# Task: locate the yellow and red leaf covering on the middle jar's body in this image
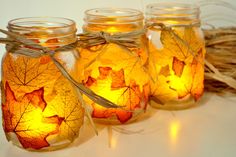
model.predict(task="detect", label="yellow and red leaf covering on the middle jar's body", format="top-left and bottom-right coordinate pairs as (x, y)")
top-left (78, 43), bottom-right (150, 123)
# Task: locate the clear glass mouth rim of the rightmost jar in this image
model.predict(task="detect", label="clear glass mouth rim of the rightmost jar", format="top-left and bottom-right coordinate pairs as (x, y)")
top-left (146, 2), bottom-right (200, 18)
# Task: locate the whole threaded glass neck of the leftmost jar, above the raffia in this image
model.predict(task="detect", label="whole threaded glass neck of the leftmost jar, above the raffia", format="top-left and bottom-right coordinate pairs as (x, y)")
top-left (7, 17), bottom-right (77, 47)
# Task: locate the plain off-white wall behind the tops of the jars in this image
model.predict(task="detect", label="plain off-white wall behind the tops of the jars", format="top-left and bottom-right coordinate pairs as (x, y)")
top-left (0, 0), bottom-right (236, 54)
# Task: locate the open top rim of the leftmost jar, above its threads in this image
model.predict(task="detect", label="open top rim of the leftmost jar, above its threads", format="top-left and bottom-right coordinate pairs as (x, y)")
top-left (8, 17), bottom-right (75, 30)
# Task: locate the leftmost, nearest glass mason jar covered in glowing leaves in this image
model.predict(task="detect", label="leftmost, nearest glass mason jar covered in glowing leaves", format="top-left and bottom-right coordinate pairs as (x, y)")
top-left (2, 17), bottom-right (84, 151)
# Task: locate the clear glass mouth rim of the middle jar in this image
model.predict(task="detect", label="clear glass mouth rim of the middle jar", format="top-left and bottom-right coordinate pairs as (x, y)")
top-left (84, 8), bottom-right (144, 23)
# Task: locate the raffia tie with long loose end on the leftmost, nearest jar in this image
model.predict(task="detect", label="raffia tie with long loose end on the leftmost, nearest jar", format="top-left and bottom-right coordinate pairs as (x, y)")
top-left (0, 29), bottom-right (123, 108)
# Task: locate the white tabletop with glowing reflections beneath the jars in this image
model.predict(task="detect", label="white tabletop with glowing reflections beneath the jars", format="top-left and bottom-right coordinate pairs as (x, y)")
top-left (0, 93), bottom-right (236, 157)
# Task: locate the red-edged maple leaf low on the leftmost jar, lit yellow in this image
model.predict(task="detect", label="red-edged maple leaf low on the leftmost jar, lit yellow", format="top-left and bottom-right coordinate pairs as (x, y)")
top-left (2, 82), bottom-right (64, 149)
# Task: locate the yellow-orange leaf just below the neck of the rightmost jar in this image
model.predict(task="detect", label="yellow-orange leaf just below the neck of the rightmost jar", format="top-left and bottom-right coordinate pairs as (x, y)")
top-left (161, 27), bottom-right (204, 63)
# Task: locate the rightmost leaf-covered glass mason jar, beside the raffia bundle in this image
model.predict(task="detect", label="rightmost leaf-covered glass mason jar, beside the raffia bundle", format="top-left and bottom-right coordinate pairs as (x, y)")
top-left (146, 3), bottom-right (205, 110)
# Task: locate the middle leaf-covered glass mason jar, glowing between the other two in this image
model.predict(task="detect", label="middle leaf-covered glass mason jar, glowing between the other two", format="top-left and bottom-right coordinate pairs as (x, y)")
top-left (77, 8), bottom-right (149, 124)
